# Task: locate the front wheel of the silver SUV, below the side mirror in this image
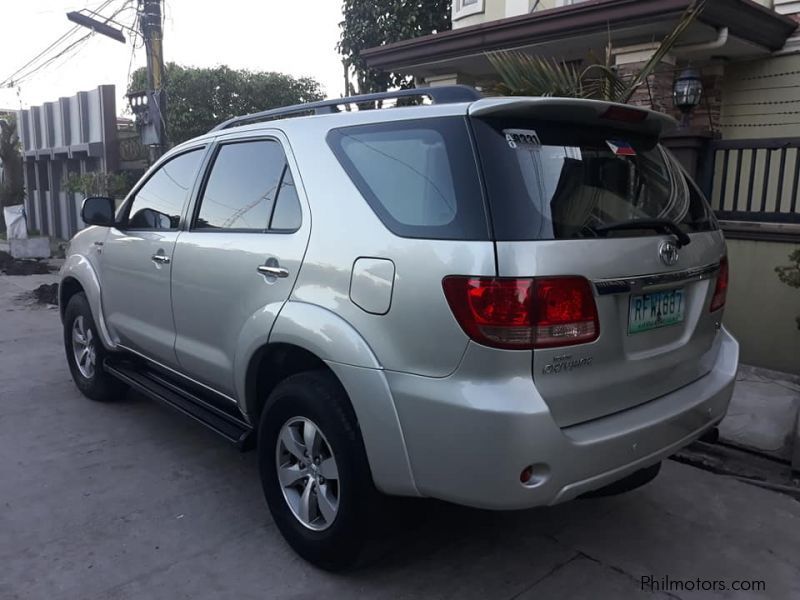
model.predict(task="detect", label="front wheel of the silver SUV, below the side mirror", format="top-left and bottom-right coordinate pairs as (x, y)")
top-left (64, 292), bottom-right (125, 402)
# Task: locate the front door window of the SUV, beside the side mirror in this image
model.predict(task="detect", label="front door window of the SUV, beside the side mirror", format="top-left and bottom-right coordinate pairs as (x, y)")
top-left (128, 148), bottom-right (203, 229)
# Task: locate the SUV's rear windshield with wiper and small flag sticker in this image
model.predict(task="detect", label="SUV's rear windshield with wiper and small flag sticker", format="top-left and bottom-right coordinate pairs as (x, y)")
top-left (473, 119), bottom-right (717, 240)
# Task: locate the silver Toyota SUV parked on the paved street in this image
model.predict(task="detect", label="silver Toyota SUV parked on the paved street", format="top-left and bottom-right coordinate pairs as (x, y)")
top-left (60, 86), bottom-right (738, 569)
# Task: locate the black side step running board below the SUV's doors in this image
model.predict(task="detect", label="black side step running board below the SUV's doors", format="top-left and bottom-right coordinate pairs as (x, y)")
top-left (103, 360), bottom-right (253, 450)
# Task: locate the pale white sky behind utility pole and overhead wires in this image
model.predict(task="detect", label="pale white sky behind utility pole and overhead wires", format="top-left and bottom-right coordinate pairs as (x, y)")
top-left (0, 0), bottom-right (344, 115)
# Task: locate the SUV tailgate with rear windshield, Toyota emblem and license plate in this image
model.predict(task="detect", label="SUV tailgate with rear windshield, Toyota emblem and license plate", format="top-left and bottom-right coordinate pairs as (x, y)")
top-left (472, 114), bottom-right (725, 426)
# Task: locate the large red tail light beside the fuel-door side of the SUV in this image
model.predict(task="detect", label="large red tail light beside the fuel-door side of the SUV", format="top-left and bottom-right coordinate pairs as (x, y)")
top-left (442, 276), bottom-right (600, 350)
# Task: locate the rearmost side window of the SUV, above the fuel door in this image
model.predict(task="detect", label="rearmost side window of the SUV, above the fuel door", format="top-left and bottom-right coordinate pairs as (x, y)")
top-left (328, 117), bottom-right (488, 240)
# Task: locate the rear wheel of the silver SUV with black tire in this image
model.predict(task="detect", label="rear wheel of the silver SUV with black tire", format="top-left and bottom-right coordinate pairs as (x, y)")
top-left (258, 371), bottom-right (379, 571)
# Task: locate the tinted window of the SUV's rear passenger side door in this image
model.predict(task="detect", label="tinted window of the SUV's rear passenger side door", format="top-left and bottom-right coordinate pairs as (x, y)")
top-left (195, 140), bottom-right (286, 231)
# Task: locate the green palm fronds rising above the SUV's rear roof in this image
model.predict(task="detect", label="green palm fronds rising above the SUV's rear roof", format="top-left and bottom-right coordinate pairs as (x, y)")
top-left (486, 0), bottom-right (705, 103)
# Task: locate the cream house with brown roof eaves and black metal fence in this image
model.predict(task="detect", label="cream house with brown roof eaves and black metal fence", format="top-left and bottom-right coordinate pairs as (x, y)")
top-left (362, 0), bottom-right (800, 374)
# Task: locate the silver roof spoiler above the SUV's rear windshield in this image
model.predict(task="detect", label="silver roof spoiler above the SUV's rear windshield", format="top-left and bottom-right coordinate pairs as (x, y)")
top-left (468, 96), bottom-right (678, 137)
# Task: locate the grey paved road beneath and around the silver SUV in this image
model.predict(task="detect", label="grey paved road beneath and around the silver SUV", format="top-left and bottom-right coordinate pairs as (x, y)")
top-left (0, 276), bottom-right (800, 600)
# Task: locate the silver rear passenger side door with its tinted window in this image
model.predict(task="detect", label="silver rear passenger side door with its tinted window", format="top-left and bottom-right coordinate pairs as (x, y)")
top-left (172, 134), bottom-right (311, 397)
